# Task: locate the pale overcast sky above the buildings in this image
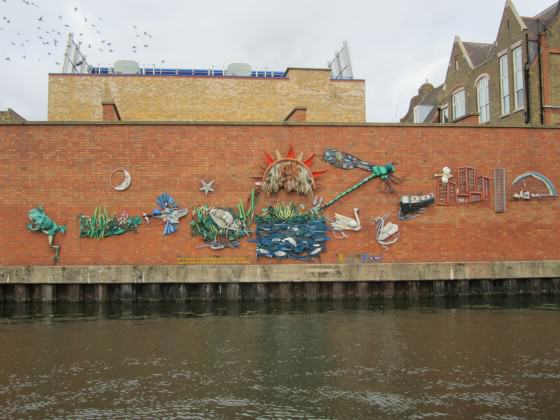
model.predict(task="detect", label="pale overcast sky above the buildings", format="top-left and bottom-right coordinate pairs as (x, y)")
top-left (0, 0), bottom-right (554, 122)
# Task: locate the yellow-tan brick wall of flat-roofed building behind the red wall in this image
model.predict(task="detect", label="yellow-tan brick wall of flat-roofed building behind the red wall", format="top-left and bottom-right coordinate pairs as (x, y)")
top-left (48, 68), bottom-right (365, 123)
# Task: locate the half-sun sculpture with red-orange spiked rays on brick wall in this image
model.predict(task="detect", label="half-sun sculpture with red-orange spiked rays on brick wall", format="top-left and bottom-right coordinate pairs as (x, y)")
top-left (260, 146), bottom-right (326, 195)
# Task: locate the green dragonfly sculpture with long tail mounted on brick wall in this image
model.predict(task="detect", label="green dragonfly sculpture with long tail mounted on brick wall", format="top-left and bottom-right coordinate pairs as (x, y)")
top-left (321, 149), bottom-right (404, 210)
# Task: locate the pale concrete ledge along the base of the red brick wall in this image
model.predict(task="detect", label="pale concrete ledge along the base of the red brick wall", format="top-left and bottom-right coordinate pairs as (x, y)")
top-left (0, 261), bottom-right (560, 284)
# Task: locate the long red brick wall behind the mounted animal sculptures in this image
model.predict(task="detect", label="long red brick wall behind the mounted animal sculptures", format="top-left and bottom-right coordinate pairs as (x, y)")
top-left (0, 124), bottom-right (560, 265)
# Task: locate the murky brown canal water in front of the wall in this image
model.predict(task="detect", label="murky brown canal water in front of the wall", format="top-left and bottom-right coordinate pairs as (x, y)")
top-left (0, 298), bottom-right (560, 419)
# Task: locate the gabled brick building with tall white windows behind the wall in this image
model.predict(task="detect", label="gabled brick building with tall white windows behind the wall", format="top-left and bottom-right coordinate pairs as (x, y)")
top-left (401, 0), bottom-right (560, 125)
